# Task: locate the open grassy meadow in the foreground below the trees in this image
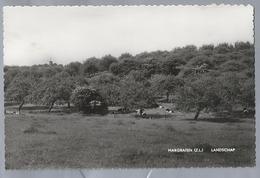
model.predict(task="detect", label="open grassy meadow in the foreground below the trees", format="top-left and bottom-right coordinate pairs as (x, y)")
top-left (5, 105), bottom-right (255, 169)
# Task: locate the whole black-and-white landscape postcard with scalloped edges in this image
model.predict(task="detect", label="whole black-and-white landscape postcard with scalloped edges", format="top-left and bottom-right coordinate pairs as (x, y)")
top-left (3, 4), bottom-right (256, 170)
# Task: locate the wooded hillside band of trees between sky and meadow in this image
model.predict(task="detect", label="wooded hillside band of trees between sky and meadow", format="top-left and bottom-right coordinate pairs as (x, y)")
top-left (4, 42), bottom-right (255, 119)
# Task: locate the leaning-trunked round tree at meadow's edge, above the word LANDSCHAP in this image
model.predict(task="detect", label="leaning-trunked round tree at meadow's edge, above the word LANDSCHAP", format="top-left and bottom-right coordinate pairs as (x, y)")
top-left (176, 75), bottom-right (221, 120)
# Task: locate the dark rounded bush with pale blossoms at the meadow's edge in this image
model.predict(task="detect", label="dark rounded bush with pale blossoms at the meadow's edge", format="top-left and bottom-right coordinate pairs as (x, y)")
top-left (71, 87), bottom-right (108, 114)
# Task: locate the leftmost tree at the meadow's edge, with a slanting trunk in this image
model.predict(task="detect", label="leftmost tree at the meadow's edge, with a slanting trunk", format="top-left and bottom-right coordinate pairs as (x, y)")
top-left (6, 75), bottom-right (32, 113)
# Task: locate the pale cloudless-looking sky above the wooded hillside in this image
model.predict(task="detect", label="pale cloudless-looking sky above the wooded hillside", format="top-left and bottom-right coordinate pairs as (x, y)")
top-left (4, 5), bottom-right (254, 65)
